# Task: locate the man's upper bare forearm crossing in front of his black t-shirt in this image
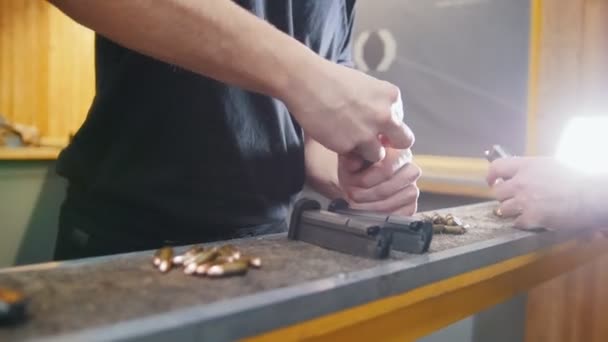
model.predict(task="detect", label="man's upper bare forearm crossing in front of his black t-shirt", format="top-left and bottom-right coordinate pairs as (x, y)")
top-left (49, 0), bottom-right (323, 98)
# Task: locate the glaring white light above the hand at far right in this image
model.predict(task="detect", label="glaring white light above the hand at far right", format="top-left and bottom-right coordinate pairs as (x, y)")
top-left (556, 115), bottom-right (608, 174)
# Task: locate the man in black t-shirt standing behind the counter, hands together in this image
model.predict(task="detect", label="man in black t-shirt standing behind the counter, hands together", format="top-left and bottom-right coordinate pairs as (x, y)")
top-left (51, 0), bottom-right (420, 259)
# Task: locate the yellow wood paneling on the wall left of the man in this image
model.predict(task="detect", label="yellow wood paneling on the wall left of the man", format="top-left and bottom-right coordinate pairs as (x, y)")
top-left (0, 0), bottom-right (95, 143)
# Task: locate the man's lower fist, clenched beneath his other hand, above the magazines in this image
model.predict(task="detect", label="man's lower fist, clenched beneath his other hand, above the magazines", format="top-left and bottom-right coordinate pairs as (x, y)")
top-left (338, 148), bottom-right (420, 216)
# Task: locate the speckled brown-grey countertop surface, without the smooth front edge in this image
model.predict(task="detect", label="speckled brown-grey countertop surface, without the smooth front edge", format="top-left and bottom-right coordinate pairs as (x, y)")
top-left (0, 203), bottom-right (530, 341)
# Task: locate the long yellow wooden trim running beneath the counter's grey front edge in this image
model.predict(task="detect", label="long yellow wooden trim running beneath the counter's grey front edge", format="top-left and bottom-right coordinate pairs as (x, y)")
top-left (246, 237), bottom-right (608, 342)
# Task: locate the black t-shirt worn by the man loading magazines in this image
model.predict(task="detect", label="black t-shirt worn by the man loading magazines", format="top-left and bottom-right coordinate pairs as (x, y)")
top-left (57, 0), bottom-right (354, 238)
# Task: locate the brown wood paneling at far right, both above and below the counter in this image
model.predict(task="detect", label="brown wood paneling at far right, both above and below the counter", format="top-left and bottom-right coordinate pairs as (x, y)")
top-left (526, 0), bottom-right (608, 342)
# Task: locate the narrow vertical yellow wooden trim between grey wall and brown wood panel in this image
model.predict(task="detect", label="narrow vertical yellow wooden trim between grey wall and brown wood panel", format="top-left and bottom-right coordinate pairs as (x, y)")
top-left (526, 0), bottom-right (543, 155)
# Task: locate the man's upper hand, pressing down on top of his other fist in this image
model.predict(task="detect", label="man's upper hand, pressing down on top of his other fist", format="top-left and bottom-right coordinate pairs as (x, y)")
top-left (282, 62), bottom-right (414, 162)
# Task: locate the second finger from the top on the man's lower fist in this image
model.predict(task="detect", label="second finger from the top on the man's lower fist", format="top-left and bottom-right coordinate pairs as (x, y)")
top-left (349, 164), bottom-right (421, 203)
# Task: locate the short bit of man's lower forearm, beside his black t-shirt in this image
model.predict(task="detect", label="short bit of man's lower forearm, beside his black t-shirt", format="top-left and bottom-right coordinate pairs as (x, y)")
top-left (305, 137), bottom-right (343, 199)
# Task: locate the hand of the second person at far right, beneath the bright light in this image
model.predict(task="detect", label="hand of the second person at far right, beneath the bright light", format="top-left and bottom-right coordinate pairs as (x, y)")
top-left (487, 158), bottom-right (594, 229)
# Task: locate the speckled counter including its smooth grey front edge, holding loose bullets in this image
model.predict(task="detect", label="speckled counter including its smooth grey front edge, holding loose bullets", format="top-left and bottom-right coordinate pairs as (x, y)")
top-left (0, 203), bottom-right (556, 341)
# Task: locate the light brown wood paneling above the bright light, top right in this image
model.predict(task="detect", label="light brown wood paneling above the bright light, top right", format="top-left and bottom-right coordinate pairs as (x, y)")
top-left (532, 0), bottom-right (608, 154)
